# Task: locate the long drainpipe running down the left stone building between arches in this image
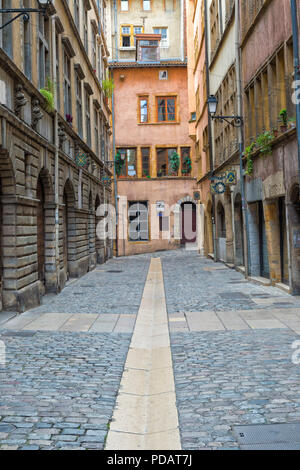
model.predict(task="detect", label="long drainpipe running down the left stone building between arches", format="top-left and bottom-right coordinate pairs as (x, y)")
top-left (52, 13), bottom-right (60, 291)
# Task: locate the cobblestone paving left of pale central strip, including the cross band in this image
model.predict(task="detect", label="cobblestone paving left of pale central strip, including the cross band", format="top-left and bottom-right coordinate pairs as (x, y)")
top-left (0, 257), bottom-right (150, 450)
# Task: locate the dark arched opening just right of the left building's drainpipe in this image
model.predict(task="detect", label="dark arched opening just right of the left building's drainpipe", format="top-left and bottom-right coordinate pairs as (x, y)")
top-left (63, 179), bottom-right (76, 279)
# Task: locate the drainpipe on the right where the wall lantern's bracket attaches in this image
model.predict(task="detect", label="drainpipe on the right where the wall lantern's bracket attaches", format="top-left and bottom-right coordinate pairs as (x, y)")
top-left (235, 0), bottom-right (251, 277)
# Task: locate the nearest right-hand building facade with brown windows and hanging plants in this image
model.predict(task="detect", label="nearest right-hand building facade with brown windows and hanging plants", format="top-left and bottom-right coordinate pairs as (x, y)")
top-left (241, 0), bottom-right (300, 293)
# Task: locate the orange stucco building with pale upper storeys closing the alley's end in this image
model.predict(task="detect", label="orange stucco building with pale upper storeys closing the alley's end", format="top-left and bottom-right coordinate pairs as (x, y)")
top-left (110, 2), bottom-right (198, 256)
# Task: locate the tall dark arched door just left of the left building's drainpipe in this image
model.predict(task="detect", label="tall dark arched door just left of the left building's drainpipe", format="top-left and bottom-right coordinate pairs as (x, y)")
top-left (37, 179), bottom-right (45, 284)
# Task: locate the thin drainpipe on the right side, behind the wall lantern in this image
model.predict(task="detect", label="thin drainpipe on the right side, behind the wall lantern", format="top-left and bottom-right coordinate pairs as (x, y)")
top-left (204, 0), bottom-right (217, 262)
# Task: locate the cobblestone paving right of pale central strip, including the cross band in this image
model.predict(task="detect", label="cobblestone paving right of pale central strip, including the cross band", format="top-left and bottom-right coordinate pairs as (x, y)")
top-left (162, 251), bottom-right (300, 450)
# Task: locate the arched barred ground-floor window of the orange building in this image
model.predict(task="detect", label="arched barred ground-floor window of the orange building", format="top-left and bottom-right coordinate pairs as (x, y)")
top-left (128, 201), bottom-right (149, 242)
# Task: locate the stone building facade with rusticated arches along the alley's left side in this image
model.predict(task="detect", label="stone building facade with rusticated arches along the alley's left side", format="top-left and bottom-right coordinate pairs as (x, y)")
top-left (0, 0), bottom-right (112, 312)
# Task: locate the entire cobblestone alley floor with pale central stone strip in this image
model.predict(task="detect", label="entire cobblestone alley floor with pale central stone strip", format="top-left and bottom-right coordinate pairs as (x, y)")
top-left (0, 250), bottom-right (300, 450)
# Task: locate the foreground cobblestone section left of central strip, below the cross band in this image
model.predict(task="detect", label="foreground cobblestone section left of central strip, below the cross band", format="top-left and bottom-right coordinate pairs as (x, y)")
top-left (0, 331), bottom-right (130, 450)
